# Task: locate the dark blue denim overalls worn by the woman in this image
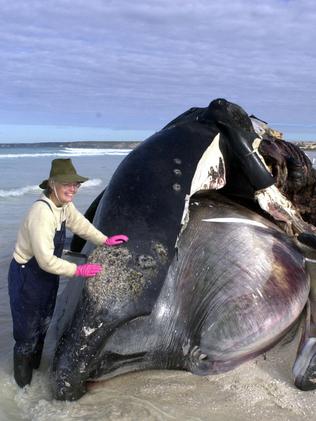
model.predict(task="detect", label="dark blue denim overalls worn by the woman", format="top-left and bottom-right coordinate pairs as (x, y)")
top-left (9, 200), bottom-right (66, 355)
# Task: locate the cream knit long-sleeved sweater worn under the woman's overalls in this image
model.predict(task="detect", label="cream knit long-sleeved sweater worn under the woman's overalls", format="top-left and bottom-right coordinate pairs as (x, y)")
top-left (13, 195), bottom-right (107, 276)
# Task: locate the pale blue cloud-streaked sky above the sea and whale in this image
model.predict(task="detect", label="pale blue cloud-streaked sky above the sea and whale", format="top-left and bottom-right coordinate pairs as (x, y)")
top-left (0, 0), bottom-right (316, 142)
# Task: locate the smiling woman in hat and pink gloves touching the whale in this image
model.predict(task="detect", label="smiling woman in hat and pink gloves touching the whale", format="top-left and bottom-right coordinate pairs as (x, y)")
top-left (9, 159), bottom-right (128, 387)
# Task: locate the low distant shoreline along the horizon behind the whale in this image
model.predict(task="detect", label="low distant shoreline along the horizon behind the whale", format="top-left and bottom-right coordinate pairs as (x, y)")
top-left (0, 140), bottom-right (316, 151)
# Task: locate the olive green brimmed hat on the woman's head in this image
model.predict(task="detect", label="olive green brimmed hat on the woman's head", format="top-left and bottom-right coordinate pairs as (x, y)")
top-left (39, 158), bottom-right (89, 189)
